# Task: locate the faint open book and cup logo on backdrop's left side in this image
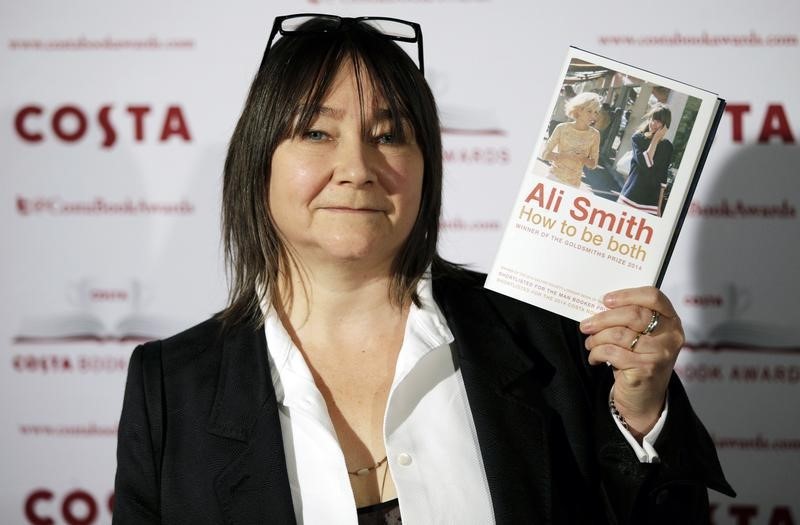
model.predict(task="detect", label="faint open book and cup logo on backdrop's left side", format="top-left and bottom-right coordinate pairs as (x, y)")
top-left (14, 279), bottom-right (186, 344)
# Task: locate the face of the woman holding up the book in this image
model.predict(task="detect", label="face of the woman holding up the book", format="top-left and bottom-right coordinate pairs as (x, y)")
top-left (269, 64), bottom-right (424, 270)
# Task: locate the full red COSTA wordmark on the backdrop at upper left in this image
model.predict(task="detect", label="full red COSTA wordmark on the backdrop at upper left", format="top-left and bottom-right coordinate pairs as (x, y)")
top-left (14, 104), bottom-right (192, 148)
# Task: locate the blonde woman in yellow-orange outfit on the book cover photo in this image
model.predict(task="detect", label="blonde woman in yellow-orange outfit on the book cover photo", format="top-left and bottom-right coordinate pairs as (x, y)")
top-left (542, 93), bottom-right (602, 188)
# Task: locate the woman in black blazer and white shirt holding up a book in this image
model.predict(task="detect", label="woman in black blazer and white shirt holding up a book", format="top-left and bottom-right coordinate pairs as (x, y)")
top-left (114, 16), bottom-right (730, 523)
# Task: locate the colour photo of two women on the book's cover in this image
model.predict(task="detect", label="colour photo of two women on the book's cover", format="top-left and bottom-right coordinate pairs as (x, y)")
top-left (530, 58), bottom-right (700, 216)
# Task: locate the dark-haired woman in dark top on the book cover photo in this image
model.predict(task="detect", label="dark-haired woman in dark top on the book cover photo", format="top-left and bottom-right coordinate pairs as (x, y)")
top-left (617, 103), bottom-right (673, 215)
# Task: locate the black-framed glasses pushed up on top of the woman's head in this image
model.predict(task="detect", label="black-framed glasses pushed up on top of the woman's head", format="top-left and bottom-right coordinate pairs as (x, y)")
top-left (261, 13), bottom-right (425, 75)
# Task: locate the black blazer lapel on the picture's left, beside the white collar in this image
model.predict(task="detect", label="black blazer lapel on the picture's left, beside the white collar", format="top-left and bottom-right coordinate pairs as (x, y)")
top-left (207, 327), bottom-right (295, 524)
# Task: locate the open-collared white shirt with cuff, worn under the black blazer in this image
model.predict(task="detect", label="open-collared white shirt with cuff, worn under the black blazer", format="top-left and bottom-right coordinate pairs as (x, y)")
top-left (264, 278), bottom-right (666, 525)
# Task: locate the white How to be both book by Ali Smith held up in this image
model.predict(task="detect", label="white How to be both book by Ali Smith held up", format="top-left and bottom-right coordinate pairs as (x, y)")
top-left (486, 47), bottom-right (725, 321)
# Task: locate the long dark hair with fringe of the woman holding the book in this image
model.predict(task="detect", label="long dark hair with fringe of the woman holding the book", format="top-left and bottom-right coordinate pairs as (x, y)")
top-left (218, 19), bottom-right (442, 325)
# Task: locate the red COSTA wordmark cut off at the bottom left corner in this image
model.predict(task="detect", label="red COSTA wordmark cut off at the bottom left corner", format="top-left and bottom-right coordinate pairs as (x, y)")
top-left (24, 489), bottom-right (114, 525)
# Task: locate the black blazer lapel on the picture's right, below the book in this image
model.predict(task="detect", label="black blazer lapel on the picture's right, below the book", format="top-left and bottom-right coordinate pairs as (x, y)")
top-left (434, 272), bottom-right (553, 524)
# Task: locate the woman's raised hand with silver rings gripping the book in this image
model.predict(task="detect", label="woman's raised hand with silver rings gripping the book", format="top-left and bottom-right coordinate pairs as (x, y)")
top-left (581, 286), bottom-right (684, 441)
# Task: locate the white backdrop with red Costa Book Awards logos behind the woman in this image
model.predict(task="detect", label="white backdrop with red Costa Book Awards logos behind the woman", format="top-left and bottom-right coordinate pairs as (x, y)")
top-left (0, 0), bottom-right (800, 525)
